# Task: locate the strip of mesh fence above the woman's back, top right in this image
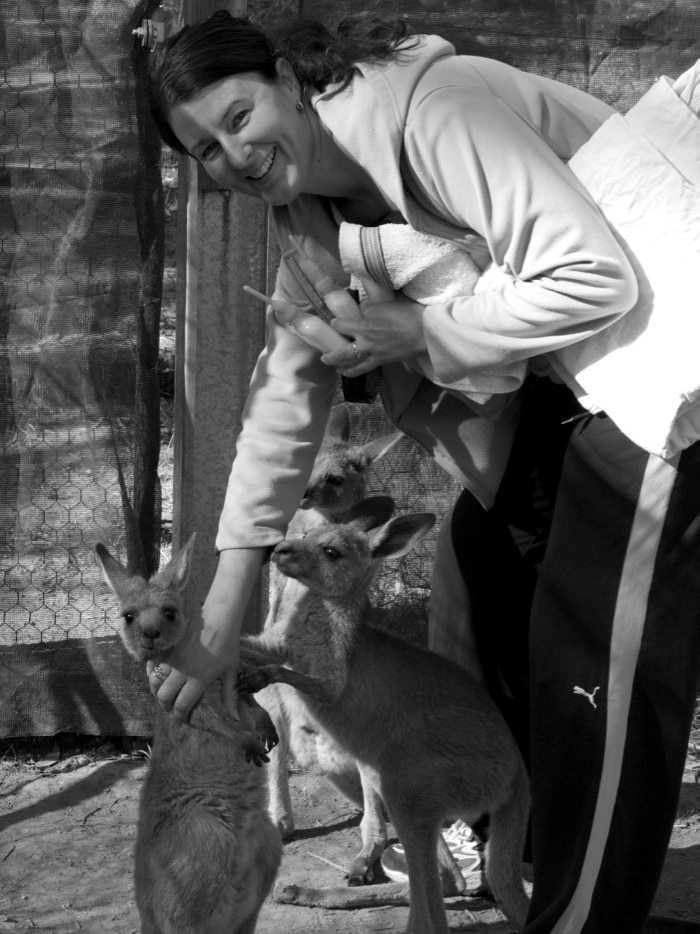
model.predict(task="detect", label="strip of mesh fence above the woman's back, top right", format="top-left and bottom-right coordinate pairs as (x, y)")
top-left (301, 0), bottom-right (700, 111)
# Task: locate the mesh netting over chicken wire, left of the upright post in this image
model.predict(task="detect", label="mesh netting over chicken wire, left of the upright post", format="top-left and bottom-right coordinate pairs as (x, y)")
top-left (0, 0), bottom-right (163, 733)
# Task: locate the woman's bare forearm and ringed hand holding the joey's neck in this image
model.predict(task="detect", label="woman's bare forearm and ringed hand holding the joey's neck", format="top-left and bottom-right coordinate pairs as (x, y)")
top-left (146, 548), bottom-right (265, 720)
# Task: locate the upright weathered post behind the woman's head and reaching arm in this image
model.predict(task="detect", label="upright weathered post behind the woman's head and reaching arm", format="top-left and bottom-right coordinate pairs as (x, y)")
top-left (173, 0), bottom-right (268, 630)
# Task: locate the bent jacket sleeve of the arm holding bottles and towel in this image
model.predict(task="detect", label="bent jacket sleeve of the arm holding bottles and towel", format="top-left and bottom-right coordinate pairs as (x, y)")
top-left (404, 86), bottom-right (637, 389)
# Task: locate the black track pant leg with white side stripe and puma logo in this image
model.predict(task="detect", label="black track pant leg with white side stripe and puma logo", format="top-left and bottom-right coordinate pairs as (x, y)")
top-left (526, 418), bottom-right (700, 934)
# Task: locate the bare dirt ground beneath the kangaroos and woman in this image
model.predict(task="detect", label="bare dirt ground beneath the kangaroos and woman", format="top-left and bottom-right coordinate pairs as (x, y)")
top-left (0, 740), bottom-right (700, 934)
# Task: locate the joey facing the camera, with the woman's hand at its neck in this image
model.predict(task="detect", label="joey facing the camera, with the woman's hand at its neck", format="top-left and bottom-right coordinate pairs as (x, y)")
top-left (95, 536), bottom-right (282, 934)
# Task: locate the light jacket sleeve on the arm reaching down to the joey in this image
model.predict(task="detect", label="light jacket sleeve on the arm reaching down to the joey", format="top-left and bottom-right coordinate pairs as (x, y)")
top-left (216, 268), bottom-right (337, 551)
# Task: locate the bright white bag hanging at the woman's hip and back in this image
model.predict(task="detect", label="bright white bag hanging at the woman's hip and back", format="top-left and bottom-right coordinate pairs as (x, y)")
top-left (550, 61), bottom-right (700, 458)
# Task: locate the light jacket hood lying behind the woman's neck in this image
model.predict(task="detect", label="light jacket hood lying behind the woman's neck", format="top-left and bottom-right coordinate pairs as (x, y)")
top-left (311, 36), bottom-right (455, 223)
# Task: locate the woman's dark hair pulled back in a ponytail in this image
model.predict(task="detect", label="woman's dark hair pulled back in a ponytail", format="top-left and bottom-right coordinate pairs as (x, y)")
top-left (150, 10), bottom-right (411, 152)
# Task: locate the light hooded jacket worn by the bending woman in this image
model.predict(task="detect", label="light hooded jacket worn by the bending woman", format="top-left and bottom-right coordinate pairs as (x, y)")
top-left (216, 36), bottom-right (637, 550)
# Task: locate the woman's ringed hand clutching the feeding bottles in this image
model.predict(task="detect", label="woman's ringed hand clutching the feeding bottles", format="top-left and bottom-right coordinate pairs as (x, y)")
top-left (321, 295), bottom-right (427, 376)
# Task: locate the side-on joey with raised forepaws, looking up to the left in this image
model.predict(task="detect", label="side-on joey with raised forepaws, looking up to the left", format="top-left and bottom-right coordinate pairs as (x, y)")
top-left (239, 498), bottom-right (529, 934)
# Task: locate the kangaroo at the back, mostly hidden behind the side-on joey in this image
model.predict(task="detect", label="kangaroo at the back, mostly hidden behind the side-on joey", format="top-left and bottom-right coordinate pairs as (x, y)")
top-left (260, 405), bottom-right (402, 885)
